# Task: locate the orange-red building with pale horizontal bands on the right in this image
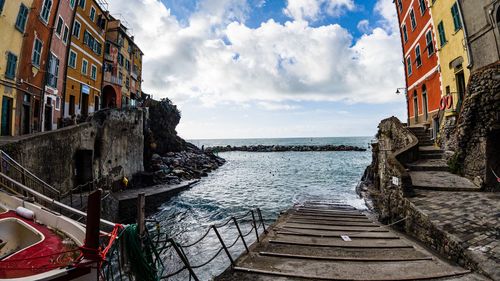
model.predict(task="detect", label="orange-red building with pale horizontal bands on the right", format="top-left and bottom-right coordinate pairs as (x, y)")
top-left (395, 0), bottom-right (441, 131)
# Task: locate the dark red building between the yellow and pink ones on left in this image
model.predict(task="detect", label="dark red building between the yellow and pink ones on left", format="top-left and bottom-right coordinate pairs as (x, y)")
top-left (15, 0), bottom-right (59, 135)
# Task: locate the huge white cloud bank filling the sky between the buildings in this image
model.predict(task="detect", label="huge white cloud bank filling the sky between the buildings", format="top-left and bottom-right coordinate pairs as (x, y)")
top-left (109, 0), bottom-right (403, 109)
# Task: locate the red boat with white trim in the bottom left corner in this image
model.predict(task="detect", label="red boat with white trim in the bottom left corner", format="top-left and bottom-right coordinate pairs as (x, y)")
top-left (0, 211), bottom-right (79, 279)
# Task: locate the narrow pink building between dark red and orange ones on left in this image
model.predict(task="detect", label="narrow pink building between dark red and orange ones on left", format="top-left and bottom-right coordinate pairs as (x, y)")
top-left (42, 0), bottom-right (77, 131)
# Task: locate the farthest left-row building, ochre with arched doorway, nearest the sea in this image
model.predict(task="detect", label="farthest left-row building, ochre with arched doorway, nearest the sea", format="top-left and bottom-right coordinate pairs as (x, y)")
top-left (103, 17), bottom-right (143, 107)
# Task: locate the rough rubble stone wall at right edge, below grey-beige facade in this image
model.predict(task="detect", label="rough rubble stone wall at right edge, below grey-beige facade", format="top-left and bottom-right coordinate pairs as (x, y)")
top-left (443, 62), bottom-right (500, 191)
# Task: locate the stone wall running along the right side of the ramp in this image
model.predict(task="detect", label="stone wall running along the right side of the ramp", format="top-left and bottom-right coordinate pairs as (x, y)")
top-left (365, 117), bottom-right (479, 274)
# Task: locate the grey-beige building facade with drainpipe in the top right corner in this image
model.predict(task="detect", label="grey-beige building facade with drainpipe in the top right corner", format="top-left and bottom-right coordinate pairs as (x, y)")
top-left (458, 0), bottom-right (500, 71)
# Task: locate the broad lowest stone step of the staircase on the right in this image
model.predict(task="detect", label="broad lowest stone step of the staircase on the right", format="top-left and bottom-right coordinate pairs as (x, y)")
top-left (409, 171), bottom-right (480, 191)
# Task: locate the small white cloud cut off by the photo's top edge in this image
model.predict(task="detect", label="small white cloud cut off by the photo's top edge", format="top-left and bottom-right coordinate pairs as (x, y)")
top-left (283, 0), bottom-right (355, 21)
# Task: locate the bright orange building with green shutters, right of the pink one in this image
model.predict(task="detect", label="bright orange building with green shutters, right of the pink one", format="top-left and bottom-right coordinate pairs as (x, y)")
top-left (64, 0), bottom-right (108, 118)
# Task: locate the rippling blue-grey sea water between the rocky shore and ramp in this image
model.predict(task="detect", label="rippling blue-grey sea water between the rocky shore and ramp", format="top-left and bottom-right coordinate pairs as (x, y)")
top-left (153, 137), bottom-right (371, 280)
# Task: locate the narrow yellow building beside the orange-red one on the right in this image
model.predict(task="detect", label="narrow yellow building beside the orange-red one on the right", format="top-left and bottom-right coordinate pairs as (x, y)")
top-left (429, 0), bottom-right (470, 122)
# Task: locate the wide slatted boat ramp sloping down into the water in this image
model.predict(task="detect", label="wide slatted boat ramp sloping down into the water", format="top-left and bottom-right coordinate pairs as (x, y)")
top-left (215, 202), bottom-right (487, 281)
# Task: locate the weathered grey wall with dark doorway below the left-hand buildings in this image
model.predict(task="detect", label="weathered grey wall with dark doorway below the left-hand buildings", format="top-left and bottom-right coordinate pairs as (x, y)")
top-left (1, 109), bottom-right (144, 192)
